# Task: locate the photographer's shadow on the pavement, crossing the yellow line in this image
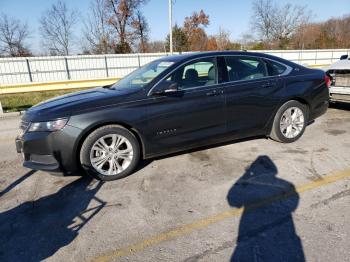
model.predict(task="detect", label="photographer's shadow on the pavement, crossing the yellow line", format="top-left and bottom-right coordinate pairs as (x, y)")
top-left (227, 156), bottom-right (305, 262)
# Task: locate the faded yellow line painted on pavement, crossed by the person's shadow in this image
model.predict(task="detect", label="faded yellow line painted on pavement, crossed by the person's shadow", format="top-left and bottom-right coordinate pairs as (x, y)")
top-left (92, 169), bottom-right (350, 262)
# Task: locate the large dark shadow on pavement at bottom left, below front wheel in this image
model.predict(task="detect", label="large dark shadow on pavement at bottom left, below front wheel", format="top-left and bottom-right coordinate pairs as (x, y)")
top-left (0, 176), bottom-right (106, 261)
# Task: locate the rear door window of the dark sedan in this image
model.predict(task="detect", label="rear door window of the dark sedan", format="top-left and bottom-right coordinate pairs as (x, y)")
top-left (225, 56), bottom-right (268, 81)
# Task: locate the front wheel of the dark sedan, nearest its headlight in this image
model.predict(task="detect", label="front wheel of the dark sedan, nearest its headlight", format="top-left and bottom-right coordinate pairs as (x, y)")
top-left (80, 125), bottom-right (140, 181)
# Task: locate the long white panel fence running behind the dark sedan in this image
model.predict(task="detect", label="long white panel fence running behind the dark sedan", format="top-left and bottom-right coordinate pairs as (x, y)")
top-left (0, 49), bottom-right (350, 87)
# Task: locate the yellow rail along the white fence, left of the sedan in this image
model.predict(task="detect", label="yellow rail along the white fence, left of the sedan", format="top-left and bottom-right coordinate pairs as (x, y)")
top-left (0, 78), bottom-right (119, 94)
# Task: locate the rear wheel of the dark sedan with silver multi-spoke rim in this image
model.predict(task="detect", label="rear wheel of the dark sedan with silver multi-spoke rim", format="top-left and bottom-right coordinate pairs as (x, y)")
top-left (270, 100), bottom-right (308, 143)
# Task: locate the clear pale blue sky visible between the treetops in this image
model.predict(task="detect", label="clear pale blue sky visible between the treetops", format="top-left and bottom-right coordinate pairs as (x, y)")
top-left (0, 0), bottom-right (350, 51)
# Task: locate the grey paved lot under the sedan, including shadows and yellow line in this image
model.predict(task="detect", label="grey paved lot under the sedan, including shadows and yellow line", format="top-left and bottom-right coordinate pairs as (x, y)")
top-left (0, 104), bottom-right (350, 261)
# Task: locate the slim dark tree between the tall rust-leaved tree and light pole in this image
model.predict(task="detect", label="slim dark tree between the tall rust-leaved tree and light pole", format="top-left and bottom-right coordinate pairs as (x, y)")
top-left (131, 10), bottom-right (149, 53)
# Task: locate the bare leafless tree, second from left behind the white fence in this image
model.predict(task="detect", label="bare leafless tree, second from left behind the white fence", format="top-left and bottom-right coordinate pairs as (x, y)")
top-left (40, 1), bottom-right (78, 55)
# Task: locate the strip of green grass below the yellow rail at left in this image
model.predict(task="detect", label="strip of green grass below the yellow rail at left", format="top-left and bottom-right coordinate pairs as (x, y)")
top-left (0, 88), bottom-right (92, 112)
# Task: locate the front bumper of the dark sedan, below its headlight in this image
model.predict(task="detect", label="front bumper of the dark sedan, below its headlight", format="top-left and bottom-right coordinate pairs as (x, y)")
top-left (15, 125), bottom-right (81, 175)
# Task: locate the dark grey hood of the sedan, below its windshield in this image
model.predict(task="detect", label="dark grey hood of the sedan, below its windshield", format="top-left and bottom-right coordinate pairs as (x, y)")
top-left (26, 87), bottom-right (140, 121)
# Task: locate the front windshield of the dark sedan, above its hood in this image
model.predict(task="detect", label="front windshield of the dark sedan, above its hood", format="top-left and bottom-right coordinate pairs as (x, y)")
top-left (110, 60), bottom-right (174, 89)
